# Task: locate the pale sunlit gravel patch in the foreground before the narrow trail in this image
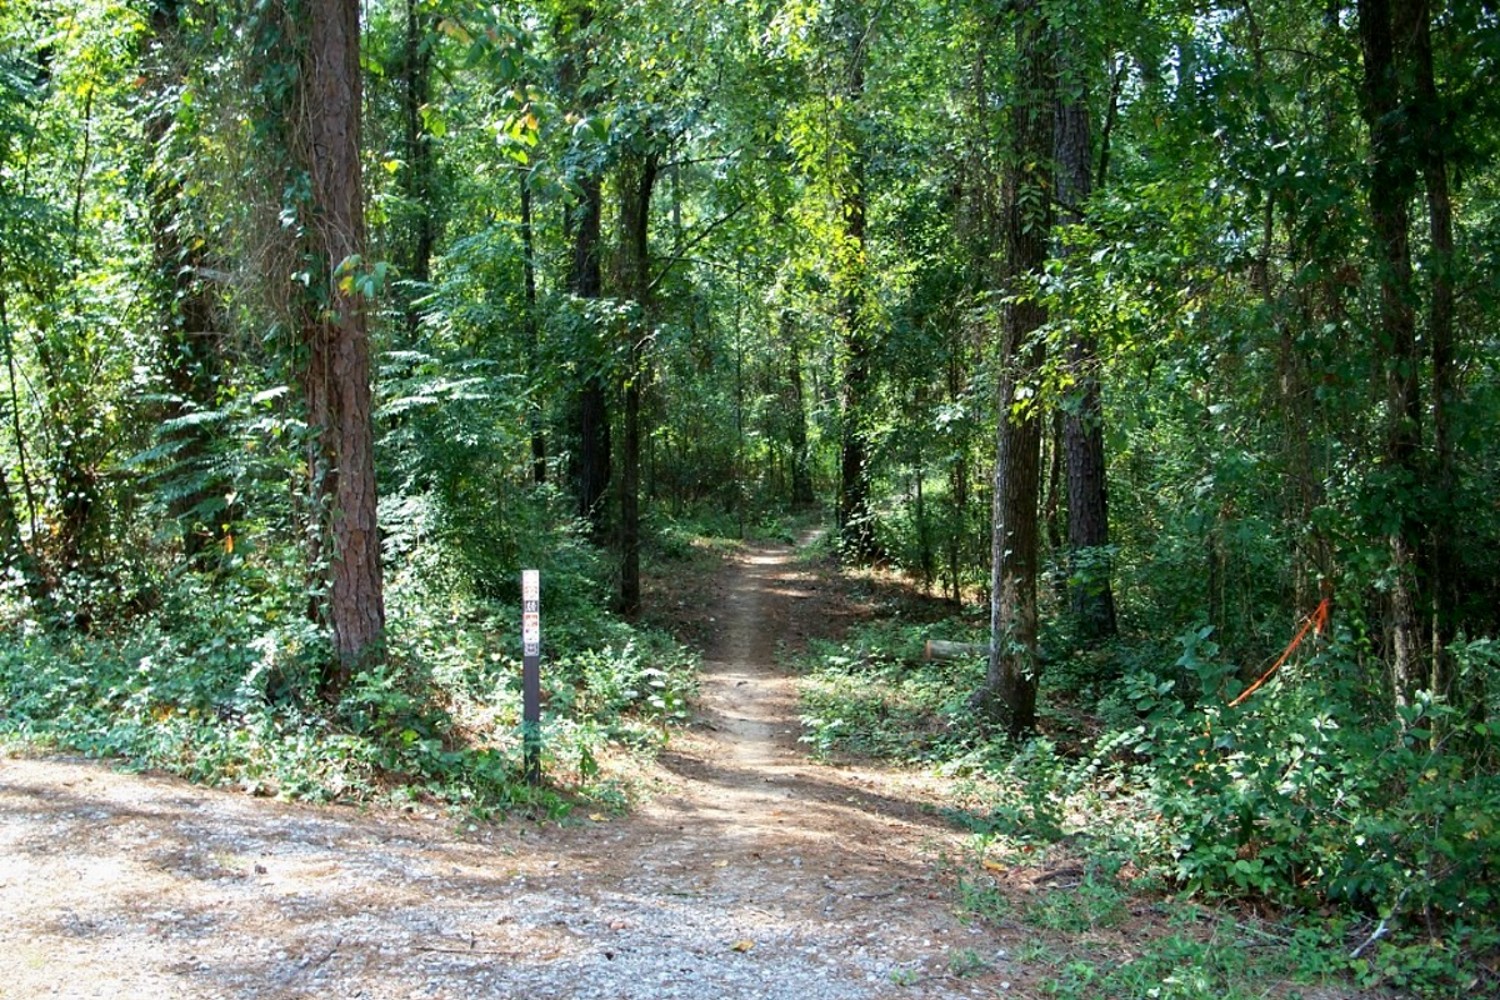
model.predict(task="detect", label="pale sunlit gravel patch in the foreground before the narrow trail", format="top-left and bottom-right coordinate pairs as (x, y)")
top-left (0, 762), bottom-right (960, 1000)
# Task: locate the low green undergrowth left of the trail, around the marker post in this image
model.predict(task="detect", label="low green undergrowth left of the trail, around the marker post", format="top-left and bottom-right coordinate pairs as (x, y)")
top-left (0, 491), bottom-right (696, 816)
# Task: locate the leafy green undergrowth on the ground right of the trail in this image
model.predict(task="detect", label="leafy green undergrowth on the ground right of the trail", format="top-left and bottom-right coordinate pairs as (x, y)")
top-left (803, 605), bottom-right (1500, 997)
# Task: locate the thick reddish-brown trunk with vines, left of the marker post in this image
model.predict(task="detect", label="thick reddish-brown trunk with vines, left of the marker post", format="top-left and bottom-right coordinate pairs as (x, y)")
top-left (294, 0), bottom-right (386, 700)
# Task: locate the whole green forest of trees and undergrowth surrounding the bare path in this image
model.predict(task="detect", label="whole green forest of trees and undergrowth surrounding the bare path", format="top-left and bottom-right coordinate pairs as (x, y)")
top-left (0, 0), bottom-right (1500, 996)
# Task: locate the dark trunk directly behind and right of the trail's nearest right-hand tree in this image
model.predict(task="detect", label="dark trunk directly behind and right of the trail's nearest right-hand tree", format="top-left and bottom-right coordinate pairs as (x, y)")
top-left (1056, 46), bottom-right (1116, 640)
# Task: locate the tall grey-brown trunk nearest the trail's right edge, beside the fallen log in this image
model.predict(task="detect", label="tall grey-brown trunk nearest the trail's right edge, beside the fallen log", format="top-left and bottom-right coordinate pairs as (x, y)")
top-left (978, 0), bottom-right (1055, 739)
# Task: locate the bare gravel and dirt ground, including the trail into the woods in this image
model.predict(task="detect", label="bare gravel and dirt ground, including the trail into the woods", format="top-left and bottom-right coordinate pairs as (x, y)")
top-left (0, 544), bottom-right (1374, 1000)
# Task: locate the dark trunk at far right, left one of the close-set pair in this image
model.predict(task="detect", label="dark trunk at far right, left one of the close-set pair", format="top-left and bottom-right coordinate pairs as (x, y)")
top-left (1359, 0), bottom-right (1424, 706)
